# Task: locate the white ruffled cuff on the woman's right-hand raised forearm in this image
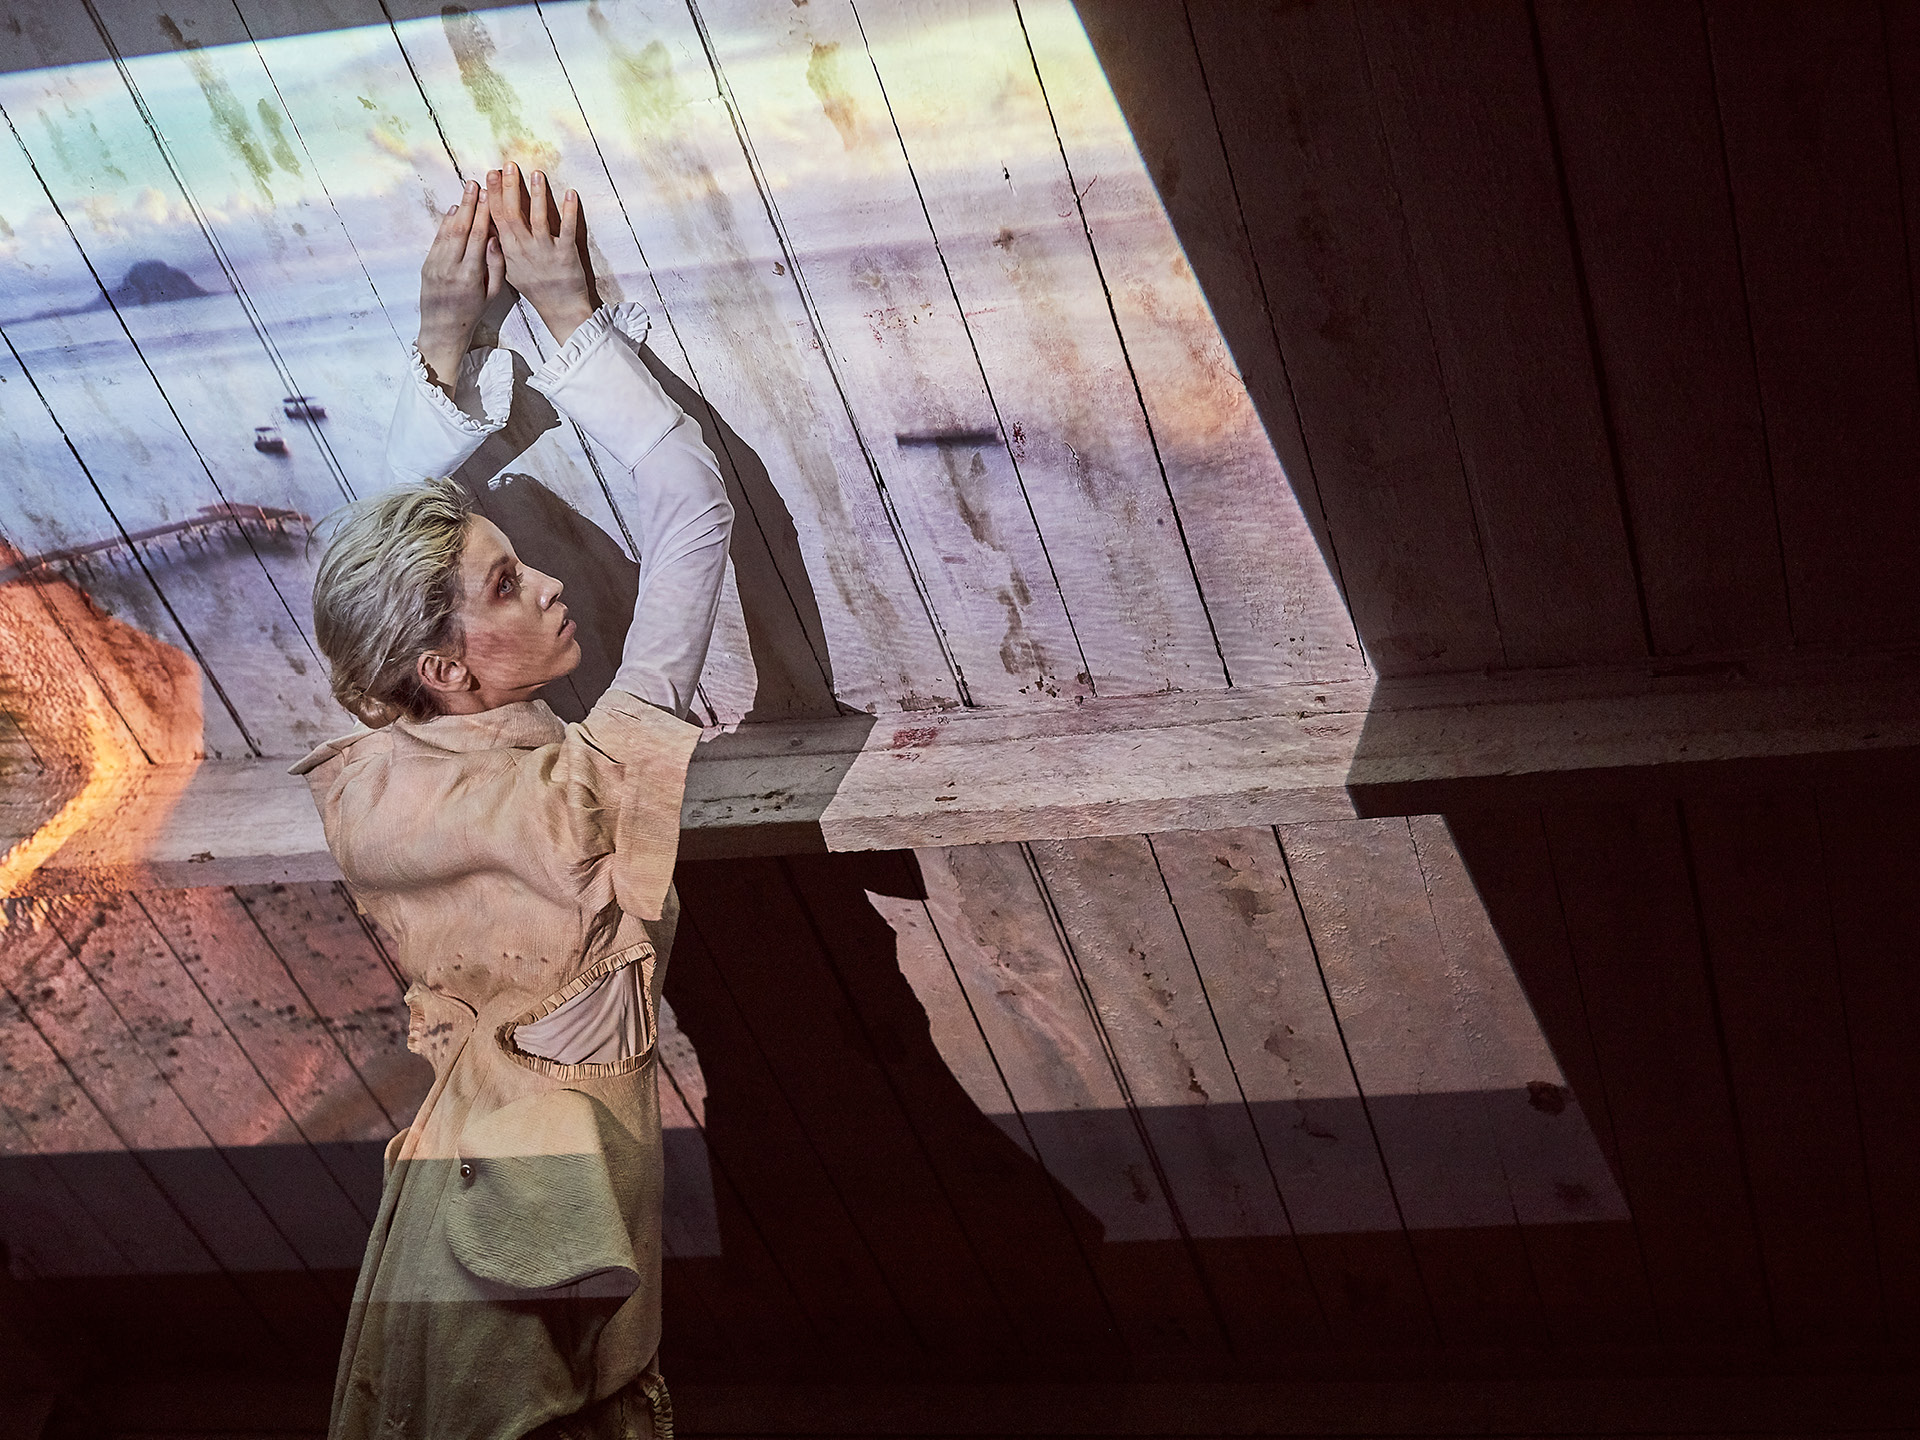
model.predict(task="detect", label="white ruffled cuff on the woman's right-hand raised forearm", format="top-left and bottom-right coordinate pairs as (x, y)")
top-left (528, 301), bottom-right (682, 470)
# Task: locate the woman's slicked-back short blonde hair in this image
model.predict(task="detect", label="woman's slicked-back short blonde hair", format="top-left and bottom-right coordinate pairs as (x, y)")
top-left (313, 480), bottom-right (472, 726)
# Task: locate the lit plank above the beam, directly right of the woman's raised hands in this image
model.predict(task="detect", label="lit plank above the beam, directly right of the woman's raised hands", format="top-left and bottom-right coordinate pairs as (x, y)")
top-left (522, 0), bottom-right (958, 714)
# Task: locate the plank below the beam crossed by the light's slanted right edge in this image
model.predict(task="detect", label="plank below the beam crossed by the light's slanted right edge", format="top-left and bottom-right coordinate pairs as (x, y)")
top-left (1413, 810), bottom-right (1653, 1344)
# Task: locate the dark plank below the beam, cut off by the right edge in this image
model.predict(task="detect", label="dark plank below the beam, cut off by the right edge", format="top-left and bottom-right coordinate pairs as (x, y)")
top-left (1818, 785), bottom-right (1920, 1342)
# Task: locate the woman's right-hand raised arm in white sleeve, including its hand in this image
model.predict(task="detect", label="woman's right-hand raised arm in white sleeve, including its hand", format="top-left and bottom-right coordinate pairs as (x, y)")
top-left (488, 165), bottom-right (733, 716)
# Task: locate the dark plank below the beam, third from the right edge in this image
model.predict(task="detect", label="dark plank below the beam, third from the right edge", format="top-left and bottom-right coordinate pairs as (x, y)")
top-left (1542, 804), bottom-right (1768, 1344)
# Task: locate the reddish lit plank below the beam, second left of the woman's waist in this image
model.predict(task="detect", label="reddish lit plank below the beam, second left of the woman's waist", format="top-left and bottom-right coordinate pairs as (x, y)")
top-left (138, 889), bottom-right (394, 1217)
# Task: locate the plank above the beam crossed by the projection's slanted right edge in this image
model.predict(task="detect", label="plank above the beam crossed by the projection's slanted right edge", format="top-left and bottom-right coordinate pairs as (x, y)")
top-left (1059, 0), bottom-right (1365, 685)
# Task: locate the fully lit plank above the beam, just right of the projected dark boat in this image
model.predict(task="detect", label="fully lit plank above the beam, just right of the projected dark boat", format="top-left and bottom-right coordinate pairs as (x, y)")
top-left (849, 0), bottom-right (1227, 695)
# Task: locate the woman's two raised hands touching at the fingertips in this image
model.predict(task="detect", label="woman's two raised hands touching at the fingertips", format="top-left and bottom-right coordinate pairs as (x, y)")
top-left (419, 161), bottom-right (599, 396)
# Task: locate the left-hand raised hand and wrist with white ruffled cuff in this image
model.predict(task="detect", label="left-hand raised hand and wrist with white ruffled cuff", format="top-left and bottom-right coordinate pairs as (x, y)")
top-left (386, 180), bottom-right (513, 480)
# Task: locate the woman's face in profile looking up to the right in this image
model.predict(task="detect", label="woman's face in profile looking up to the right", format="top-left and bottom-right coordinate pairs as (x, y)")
top-left (420, 515), bottom-right (580, 714)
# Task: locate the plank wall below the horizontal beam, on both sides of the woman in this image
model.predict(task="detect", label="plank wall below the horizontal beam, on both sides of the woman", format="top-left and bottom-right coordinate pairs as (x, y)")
top-left (0, 791), bottom-right (1912, 1379)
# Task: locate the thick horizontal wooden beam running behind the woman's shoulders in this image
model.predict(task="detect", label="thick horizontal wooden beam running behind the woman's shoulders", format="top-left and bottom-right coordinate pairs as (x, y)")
top-left (25, 660), bottom-right (1920, 895)
